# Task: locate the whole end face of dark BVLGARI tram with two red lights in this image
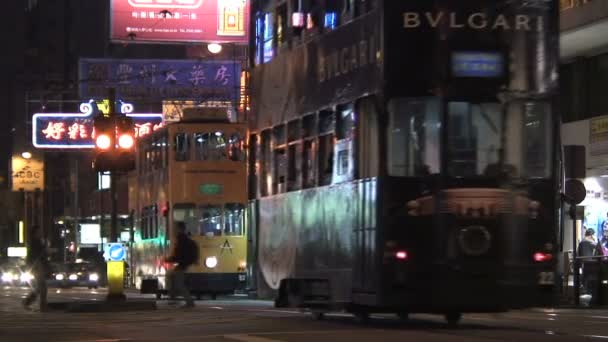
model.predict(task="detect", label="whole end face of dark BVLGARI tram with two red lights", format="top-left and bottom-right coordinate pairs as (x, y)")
top-left (382, 0), bottom-right (560, 312)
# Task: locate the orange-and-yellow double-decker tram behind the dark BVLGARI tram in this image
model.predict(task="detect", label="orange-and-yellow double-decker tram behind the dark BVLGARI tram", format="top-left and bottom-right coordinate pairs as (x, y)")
top-left (129, 108), bottom-right (247, 298)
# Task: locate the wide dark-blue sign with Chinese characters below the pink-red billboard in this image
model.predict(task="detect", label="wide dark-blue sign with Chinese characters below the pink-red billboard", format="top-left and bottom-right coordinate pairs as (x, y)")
top-left (80, 58), bottom-right (241, 102)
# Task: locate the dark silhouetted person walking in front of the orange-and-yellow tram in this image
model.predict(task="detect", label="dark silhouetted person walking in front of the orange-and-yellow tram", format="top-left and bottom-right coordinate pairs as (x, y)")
top-left (167, 222), bottom-right (198, 308)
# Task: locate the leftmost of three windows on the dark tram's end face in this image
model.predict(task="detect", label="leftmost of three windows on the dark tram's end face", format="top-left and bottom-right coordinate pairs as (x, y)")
top-left (388, 98), bottom-right (441, 177)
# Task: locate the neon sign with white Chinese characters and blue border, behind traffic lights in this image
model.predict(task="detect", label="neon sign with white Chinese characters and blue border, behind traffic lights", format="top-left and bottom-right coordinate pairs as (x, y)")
top-left (32, 100), bottom-right (163, 149)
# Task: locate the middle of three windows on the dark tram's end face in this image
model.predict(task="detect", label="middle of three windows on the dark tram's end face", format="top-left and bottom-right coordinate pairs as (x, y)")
top-left (447, 102), bottom-right (504, 177)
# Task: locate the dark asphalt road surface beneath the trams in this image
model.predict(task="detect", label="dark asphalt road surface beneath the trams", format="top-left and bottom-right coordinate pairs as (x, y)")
top-left (0, 288), bottom-right (608, 342)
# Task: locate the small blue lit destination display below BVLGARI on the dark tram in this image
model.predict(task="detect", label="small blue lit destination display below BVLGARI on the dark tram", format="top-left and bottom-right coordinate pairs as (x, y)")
top-left (452, 52), bottom-right (504, 78)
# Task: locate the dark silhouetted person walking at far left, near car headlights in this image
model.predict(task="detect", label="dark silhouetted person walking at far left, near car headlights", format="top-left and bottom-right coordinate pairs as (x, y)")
top-left (23, 226), bottom-right (50, 311)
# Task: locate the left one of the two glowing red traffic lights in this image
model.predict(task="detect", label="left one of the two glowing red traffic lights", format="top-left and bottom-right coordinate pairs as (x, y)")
top-left (93, 116), bottom-right (116, 172)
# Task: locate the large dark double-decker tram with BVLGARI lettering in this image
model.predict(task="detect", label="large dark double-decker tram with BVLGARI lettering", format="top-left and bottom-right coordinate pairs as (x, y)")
top-left (249, 0), bottom-right (560, 323)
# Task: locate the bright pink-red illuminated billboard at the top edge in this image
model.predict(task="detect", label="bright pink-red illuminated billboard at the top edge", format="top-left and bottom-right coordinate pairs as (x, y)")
top-left (110, 0), bottom-right (250, 44)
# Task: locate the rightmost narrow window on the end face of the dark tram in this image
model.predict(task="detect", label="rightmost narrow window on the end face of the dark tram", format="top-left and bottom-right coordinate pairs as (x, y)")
top-left (522, 102), bottom-right (553, 178)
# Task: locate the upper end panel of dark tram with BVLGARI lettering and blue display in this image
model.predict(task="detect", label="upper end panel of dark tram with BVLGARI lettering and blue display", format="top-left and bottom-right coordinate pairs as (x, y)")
top-left (384, 0), bottom-right (559, 96)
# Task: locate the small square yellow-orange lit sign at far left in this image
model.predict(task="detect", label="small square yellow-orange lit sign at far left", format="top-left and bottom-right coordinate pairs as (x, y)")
top-left (11, 155), bottom-right (44, 191)
